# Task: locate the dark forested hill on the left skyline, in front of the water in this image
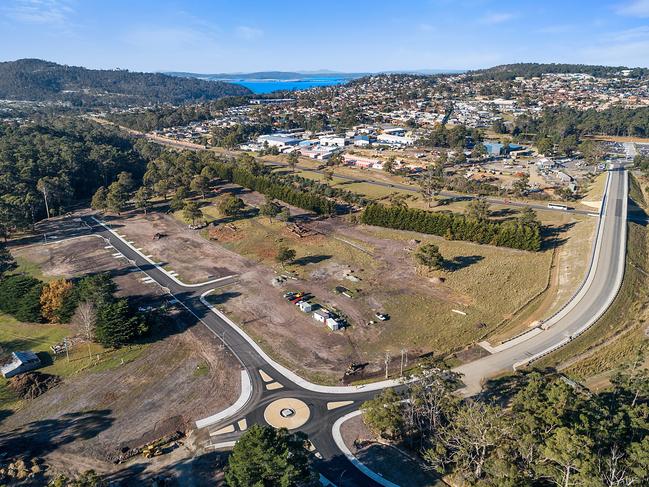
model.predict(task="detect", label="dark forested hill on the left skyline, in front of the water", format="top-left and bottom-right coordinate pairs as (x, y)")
top-left (0, 59), bottom-right (251, 106)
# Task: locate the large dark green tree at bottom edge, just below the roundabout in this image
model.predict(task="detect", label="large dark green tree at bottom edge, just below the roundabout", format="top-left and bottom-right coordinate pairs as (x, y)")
top-left (225, 424), bottom-right (312, 487)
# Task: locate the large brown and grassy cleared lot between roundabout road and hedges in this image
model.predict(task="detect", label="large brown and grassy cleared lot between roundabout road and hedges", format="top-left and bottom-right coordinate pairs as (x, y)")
top-left (101, 181), bottom-right (590, 383)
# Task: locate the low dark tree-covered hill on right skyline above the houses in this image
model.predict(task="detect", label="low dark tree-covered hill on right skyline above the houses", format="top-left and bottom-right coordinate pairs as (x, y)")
top-left (468, 63), bottom-right (649, 80)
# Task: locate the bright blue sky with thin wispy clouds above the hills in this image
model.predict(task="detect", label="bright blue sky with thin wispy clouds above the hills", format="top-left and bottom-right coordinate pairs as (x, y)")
top-left (0, 0), bottom-right (649, 73)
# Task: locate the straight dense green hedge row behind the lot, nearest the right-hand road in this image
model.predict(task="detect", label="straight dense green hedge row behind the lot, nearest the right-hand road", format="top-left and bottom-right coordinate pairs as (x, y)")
top-left (361, 203), bottom-right (542, 251)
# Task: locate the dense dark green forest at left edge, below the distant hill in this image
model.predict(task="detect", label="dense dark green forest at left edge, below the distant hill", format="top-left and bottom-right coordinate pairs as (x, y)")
top-left (0, 118), bottom-right (157, 233)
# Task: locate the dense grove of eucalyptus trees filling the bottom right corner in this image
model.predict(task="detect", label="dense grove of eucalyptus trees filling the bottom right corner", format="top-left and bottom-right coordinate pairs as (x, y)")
top-left (363, 370), bottom-right (649, 487)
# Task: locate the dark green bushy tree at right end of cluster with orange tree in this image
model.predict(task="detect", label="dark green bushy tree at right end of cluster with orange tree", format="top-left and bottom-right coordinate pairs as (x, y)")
top-left (95, 299), bottom-right (145, 348)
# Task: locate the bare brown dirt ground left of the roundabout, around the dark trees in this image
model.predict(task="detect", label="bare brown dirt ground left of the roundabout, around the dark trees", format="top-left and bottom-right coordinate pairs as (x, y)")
top-left (0, 237), bottom-right (240, 485)
